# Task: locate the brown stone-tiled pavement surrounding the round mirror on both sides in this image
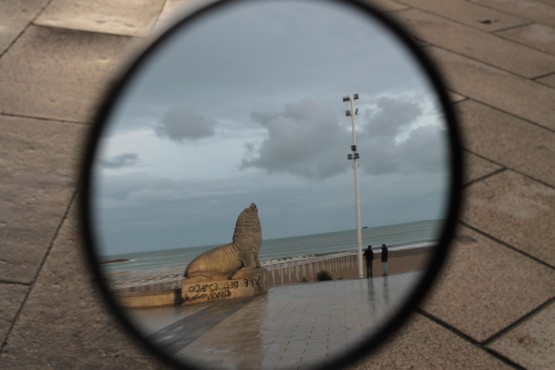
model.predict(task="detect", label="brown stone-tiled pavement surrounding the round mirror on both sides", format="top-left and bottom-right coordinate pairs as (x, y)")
top-left (0, 0), bottom-right (555, 369)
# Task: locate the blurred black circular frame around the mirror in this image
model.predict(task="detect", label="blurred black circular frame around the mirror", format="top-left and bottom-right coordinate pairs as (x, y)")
top-left (79, 0), bottom-right (463, 369)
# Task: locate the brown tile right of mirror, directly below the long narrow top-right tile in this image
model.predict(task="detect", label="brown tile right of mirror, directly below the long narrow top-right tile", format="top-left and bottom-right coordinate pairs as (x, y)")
top-left (426, 47), bottom-right (555, 130)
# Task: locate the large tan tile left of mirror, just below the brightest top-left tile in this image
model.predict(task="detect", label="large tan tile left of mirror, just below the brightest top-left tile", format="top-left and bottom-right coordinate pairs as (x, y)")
top-left (0, 26), bottom-right (137, 122)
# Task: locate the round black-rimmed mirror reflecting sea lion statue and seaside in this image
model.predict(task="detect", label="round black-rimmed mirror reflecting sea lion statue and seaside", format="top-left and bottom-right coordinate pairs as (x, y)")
top-left (82, 0), bottom-right (461, 369)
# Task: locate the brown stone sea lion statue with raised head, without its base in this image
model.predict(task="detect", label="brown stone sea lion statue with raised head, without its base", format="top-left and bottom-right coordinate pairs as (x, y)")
top-left (183, 203), bottom-right (262, 283)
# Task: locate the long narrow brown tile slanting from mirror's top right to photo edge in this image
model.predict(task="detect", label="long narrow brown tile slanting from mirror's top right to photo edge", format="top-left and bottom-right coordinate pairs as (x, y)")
top-left (396, 9), bottom-right (555, 78)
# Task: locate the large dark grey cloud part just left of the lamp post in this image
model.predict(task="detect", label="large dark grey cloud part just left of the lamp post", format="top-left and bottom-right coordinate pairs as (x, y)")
top-left (242, 100), bottom-right (349, 179)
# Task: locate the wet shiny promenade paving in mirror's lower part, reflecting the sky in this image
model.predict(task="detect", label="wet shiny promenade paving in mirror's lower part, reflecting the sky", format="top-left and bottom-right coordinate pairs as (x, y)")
top-left (128, 272), bottom-right (422, 369)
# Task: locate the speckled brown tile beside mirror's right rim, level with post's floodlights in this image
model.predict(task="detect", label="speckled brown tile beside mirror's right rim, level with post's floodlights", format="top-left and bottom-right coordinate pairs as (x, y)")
top-left (458, 100), bottom-right (555, 187)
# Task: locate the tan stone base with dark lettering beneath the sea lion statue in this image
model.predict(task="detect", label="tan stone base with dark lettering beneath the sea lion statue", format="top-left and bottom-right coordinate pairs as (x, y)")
top-left (181, 268), bottom-right (268, 305)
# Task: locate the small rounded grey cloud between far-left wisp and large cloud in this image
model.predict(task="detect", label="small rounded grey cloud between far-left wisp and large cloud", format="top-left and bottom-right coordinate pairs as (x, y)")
top-left (154, 107), bottom-right (216, 143)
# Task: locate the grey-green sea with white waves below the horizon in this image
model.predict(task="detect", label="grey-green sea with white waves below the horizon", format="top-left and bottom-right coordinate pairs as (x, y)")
top-left (101, 220), bottom-right (443, 272)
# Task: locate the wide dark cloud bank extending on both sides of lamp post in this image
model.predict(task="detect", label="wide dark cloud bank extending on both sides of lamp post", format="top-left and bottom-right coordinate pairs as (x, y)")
top-left (242, 98), bottom-right (446, 179)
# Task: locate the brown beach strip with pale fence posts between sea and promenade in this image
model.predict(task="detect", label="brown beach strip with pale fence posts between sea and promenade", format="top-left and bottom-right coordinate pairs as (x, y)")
top-left (106, 247), bottom-right (433, 293)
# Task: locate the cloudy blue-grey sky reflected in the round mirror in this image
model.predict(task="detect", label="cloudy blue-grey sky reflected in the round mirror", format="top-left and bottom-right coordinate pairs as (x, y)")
top-left (92, 0), bottom-right (449, 255)
